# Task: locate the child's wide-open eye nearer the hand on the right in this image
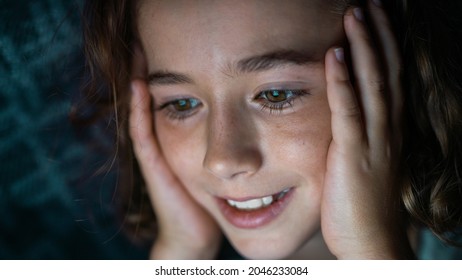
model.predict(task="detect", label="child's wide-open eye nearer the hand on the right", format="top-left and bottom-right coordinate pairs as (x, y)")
top-left (256, 89), bottom-right (309, 113)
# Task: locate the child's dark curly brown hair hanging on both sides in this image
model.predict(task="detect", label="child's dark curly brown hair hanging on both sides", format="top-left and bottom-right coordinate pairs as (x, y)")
top-left (73, 0), bottom-right (462, 245)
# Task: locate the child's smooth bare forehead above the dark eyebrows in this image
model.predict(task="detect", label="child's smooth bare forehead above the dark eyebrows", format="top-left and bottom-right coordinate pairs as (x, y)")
top-left (137, 0), bottom-right (343, 72)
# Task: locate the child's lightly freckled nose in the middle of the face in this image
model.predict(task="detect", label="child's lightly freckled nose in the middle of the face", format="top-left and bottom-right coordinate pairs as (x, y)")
top-left (203, 105), bottom-right (262, 180)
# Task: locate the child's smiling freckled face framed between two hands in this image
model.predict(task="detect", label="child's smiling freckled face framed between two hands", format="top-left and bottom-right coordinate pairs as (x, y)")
top-left (138, 0), bottom-right (344, 258)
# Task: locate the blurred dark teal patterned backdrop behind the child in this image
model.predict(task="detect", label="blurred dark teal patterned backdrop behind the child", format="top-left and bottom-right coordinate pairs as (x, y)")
top-left (0, 0), bottom-right (462, 259)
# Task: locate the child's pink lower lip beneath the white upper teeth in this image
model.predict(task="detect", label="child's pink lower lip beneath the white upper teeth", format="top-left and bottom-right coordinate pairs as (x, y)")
top-left (218, 188), bottom-right (294, 229)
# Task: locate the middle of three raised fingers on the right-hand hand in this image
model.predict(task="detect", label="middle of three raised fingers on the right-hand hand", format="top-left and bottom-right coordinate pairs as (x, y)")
top-left (344, 8), bottom-right (389, 146)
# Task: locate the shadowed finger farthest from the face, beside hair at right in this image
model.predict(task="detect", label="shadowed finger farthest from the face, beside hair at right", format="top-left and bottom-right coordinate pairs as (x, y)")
top-left (369, 0), bottom-right (404, 139)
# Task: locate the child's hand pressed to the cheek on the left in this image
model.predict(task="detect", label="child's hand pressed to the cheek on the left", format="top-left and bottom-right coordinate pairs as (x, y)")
top-left (129, 45), bottom-right (221, 259)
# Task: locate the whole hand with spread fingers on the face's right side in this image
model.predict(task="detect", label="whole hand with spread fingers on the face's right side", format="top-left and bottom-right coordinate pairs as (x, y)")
top-left (321, 1), bottom-right (412, 259)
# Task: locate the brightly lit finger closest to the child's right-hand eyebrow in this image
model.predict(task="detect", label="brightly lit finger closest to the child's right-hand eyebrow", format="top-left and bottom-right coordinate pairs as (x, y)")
top-left (325, 48), bottom-right (365, 151)
